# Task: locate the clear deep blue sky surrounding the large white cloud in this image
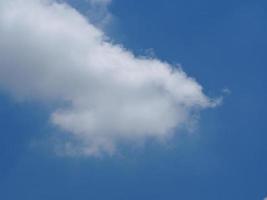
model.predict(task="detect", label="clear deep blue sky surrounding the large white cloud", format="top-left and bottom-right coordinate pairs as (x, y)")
top-left (0, 0), bottom-right (267, 200)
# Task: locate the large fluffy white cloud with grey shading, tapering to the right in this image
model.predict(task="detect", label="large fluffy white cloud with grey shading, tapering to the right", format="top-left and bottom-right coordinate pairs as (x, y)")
top-left (0, 0), bottom-right (219, 155)
